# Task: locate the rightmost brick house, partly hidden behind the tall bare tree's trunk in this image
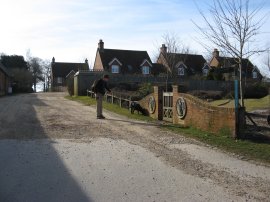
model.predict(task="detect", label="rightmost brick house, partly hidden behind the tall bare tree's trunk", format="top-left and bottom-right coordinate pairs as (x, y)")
top-left (209, 49), bottom-right (263, 81)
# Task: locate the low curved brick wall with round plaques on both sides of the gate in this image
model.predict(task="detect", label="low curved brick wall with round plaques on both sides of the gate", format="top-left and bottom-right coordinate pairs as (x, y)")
top-left (139, 86), bottom-right (245, 137)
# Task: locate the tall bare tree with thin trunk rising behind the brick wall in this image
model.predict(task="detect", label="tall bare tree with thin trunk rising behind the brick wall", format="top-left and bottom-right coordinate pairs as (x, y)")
top-left (193, 0), bottom-right (266, 107)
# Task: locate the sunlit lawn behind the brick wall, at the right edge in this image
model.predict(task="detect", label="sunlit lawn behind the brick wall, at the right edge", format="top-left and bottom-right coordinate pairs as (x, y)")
top-left (211, 95), bottom-right (270, 111)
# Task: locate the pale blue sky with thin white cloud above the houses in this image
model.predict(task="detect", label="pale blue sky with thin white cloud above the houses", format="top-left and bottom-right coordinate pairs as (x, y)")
top-left (0, 0), bottom-right (270, 76)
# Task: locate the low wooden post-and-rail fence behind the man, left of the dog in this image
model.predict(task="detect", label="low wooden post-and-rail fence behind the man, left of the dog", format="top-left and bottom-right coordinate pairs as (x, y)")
top-left (86, 90), bottom-right (132, 109)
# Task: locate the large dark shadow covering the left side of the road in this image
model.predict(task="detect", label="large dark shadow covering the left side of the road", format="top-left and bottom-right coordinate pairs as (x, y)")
top-left (0, 94), bottom-right (92, 201)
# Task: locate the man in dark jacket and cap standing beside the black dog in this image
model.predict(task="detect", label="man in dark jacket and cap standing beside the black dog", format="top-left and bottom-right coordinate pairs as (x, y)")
top-left (96, 75), bottom-right (111, 119)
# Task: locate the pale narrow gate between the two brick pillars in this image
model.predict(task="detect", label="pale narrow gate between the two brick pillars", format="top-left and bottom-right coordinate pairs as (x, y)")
top-left (163, 92), bottom-right (173, 122)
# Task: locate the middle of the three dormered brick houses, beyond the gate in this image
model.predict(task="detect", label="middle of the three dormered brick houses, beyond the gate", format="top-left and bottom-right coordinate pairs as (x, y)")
top-left (157, 44), bottom-right (207, 78)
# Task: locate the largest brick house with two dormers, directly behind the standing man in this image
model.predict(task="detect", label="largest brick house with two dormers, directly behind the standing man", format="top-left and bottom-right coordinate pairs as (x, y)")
top-left (93, 40), bottom-right (154, 75)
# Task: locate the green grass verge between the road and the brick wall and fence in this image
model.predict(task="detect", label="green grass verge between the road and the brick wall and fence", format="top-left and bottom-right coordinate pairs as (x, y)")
top-left (66, 96), bottom-right (270, 164)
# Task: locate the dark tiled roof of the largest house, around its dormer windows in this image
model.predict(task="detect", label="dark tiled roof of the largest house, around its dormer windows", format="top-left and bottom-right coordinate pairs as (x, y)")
top-left (99, 49), bottom-right (152, 73)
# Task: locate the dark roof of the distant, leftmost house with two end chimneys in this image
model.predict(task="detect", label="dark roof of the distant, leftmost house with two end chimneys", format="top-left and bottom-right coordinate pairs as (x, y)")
top-left (52, 62), bottom-right (89, 77)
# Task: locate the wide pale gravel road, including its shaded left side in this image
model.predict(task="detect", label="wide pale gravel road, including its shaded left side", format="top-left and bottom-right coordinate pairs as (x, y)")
top-left (0, 93), bottom-right (270, 202)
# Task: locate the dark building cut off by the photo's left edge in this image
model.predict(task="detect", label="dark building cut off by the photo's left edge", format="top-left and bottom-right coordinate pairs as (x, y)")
top-left (0, 62), bottom-right (11, 96)
